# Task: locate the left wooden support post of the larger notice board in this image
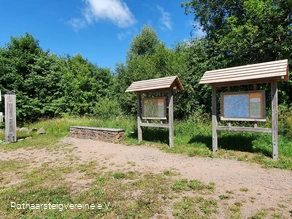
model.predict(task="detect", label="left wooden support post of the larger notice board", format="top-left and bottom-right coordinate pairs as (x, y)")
top-left (212, 86), bottom-right (218, 152)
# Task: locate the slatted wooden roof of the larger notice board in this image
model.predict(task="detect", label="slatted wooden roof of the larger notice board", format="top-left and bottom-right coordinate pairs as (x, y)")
top-left (200, 59), bottom-right (289, 85)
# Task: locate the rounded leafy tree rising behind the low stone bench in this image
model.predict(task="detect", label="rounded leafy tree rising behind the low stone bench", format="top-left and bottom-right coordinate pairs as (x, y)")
top-left (60, 54), bottom-right (112, 115)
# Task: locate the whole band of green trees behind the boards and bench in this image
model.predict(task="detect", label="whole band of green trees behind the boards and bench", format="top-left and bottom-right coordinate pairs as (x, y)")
top-left (0, 0), bottom-right (292, 137)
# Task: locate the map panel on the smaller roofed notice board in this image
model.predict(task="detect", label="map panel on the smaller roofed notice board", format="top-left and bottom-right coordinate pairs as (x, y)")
top-left (143, 97), bottom-right (166, 118)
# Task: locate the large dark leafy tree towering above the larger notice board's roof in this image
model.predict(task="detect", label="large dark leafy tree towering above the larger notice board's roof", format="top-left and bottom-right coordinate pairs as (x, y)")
top-left (182, 0), bottom-right (292, 66)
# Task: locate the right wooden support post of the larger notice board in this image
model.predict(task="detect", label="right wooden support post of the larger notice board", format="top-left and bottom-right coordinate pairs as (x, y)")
top-left (271, 80), bottom-right (278, 160)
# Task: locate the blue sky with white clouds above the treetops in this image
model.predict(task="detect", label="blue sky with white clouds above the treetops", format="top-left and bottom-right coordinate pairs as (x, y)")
top-left (0, 0), bottom-right (202, 70)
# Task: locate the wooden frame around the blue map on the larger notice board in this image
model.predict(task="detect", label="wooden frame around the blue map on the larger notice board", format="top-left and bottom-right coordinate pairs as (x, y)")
top-left (220, 90), bottom-right (266, 122)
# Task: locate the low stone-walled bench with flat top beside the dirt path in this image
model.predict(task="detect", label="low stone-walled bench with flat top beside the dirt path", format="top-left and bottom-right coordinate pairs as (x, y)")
top-left (70, 126), bottom-right (125, 142)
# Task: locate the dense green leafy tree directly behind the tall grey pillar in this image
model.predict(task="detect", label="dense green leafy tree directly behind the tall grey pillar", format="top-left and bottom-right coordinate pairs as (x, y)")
top-left (0, 33), bottom-right (60, 121)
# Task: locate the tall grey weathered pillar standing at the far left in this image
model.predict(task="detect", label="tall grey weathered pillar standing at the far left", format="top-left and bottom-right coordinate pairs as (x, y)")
top-left (4, 94), bottom-right (16, 143)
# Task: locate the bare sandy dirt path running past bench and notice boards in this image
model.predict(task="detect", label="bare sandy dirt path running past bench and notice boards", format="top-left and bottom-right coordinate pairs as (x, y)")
top-left (0, 137), bottom-right (292, 218)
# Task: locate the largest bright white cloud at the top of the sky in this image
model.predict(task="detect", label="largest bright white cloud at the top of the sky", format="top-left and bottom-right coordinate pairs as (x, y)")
top-left (68, 0), bottom-right (136, 30)
